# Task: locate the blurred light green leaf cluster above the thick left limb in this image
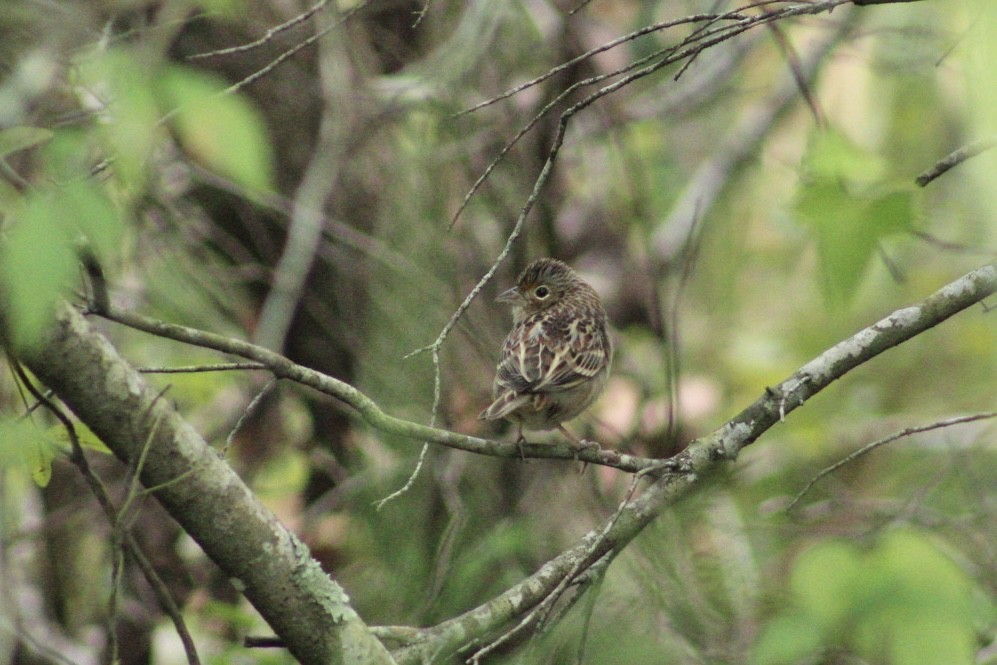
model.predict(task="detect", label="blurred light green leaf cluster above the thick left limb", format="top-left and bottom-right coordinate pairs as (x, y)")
top-left (0, 47), bottom-right (272, 351)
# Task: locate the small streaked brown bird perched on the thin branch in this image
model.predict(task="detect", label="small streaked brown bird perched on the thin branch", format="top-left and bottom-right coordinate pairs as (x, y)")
top-left (478, 258), bottom-right (613, 449)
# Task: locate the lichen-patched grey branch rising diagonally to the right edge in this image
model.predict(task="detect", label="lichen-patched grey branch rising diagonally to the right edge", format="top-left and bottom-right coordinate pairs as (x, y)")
top-left (395, 264), bottom-right (997, 665)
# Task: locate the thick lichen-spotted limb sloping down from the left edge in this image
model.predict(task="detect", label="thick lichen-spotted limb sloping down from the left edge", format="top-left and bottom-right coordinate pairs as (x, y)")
top-left (10, 304), bottom-right (393, 665)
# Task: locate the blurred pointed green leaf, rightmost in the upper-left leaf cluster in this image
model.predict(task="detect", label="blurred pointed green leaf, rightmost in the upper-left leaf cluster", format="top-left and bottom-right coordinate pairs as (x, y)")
top-left (156, 66), bottom-right (273, 193)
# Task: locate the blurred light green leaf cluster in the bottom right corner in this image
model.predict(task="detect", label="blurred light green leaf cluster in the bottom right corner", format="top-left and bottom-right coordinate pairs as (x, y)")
top-left (752, 530), bottom-right (980, 665)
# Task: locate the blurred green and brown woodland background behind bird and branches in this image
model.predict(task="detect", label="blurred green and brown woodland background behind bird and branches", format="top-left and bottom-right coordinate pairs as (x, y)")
top-left (0, 0), bottom-right (997, 665)
